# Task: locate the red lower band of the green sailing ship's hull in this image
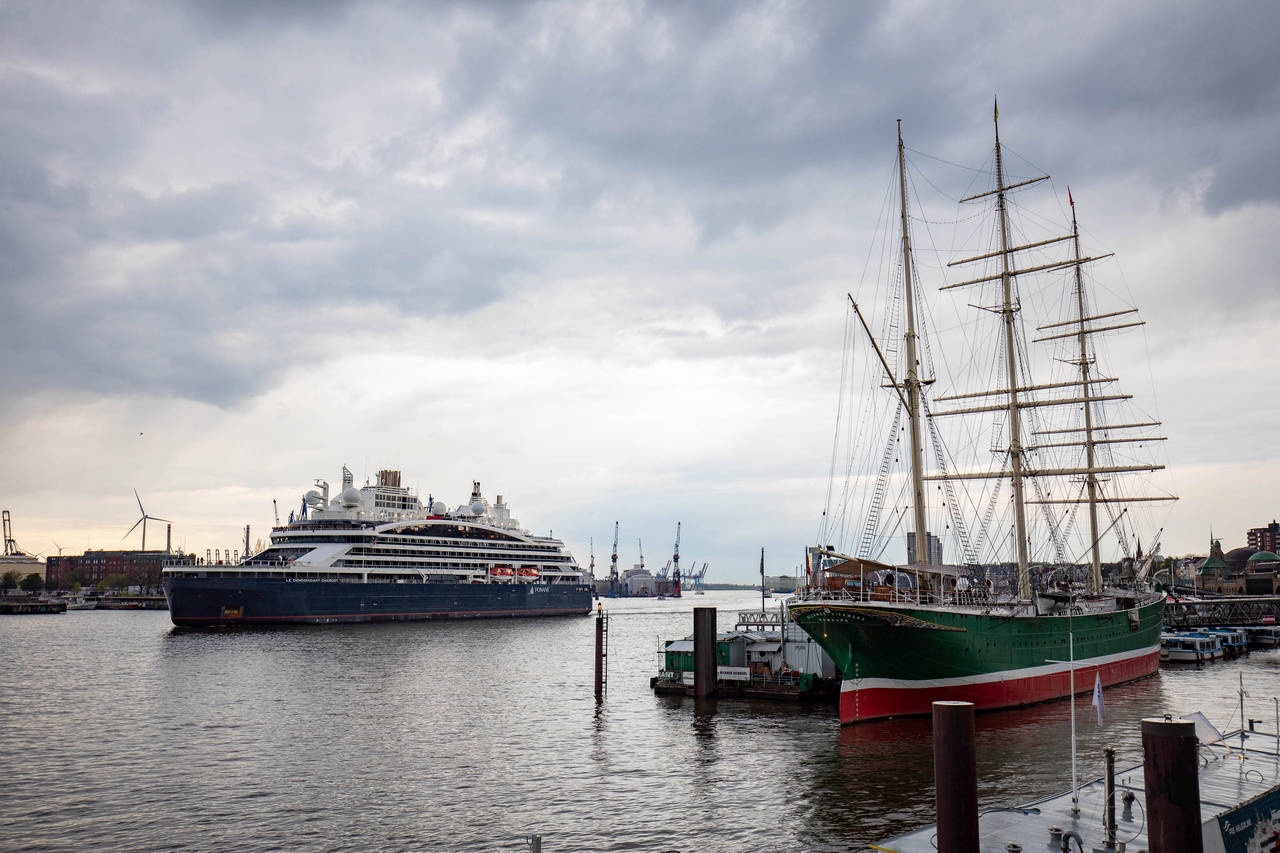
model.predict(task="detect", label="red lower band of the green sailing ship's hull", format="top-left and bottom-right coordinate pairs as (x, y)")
top-left (840, 646), bottom-right (1160, 725)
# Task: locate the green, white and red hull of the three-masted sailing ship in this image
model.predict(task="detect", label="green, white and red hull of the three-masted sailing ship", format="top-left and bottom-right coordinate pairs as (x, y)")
top-left (791, 591), bottom-right (1162, 724)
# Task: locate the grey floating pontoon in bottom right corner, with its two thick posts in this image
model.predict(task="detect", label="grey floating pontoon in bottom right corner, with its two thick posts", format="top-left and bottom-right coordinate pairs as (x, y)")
top-left (872, 702), bottom-right (1280, 853)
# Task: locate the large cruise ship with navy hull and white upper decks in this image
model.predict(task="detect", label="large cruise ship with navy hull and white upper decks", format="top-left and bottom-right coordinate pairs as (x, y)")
top-left (164, 467), bottom-right (591, 626)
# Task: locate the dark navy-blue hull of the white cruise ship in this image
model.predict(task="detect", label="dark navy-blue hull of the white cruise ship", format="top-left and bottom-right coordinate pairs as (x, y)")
top-left (164, 578), bottom-right (591, 626)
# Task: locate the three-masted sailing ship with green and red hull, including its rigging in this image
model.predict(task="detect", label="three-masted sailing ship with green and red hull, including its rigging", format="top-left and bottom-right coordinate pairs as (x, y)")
top-left (790, 111), bottom-right (1174, 724)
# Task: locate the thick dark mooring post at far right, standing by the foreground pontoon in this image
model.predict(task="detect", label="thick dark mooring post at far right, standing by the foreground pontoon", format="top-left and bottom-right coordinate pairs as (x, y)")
top-left (1142, 717), bottom-right (1204, 853)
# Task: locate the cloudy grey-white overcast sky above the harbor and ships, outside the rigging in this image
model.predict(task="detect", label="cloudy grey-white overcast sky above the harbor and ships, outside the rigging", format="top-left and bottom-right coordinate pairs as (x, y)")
top-left (0, 0), bottom-right (1280, 581)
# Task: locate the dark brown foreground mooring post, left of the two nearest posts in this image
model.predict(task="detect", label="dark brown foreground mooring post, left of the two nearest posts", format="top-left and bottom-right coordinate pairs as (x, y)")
top-left (933, 702), bottom-right (978, 853)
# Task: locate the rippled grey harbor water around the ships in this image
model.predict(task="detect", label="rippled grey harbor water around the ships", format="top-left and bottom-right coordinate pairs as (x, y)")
top-left (0, 590), bottom-right (1280, 853)
